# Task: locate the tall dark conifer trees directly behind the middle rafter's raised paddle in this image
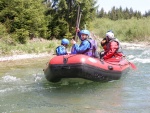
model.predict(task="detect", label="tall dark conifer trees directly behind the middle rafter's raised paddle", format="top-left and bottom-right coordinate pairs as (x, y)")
top-left (47, 0), bottom-right (96, 38)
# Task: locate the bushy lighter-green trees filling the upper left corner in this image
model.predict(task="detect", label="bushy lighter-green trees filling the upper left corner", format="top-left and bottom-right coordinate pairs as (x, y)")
top-left (0, 0), bottom-right (47, 43)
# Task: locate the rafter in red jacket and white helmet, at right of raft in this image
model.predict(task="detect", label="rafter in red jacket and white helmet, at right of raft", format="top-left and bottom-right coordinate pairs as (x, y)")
top-left (100, 30), bottom-right (124, 61)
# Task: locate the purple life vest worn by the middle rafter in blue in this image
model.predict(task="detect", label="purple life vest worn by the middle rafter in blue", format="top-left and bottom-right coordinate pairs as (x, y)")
top-left (83, 38), bottom-right (97, 57)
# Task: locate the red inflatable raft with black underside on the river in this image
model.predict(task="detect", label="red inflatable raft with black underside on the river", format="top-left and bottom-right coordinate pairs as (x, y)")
top-left (44, 54), bottom-right (130, 82)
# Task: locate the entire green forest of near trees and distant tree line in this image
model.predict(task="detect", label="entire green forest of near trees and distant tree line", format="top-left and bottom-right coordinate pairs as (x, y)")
top-left (0, 0), bottom-right (150, 44)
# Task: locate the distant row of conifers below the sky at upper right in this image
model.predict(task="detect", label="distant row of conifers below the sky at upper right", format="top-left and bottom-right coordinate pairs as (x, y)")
top-left (97, 6), bottom-right (150, 20)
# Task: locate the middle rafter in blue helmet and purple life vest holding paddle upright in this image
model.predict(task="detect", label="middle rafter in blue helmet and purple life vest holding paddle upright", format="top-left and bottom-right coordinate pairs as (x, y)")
top-left (71, 28), bottom-right (99, 57)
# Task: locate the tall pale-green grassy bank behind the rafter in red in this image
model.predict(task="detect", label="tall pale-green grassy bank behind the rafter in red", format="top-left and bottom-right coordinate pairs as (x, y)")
top-left (90, 18), bottom-right (150, 42)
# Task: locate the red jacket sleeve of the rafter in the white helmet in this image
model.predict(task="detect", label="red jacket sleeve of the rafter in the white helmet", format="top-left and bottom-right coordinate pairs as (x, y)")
top-left (103, 41), bottom-right (119, 59)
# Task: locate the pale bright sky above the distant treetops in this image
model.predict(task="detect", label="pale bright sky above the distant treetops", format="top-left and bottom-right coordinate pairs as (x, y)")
top-left (97, 0), bottom-right (150, 14)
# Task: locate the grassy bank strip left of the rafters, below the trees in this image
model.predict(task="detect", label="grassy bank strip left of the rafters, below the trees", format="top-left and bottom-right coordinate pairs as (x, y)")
top-left (0, 39), bottom-right (60, 56)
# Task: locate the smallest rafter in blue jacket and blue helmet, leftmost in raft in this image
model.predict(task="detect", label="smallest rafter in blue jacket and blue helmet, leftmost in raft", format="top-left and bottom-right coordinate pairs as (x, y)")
top-left (56, 38), bottom-right (69, 56)
